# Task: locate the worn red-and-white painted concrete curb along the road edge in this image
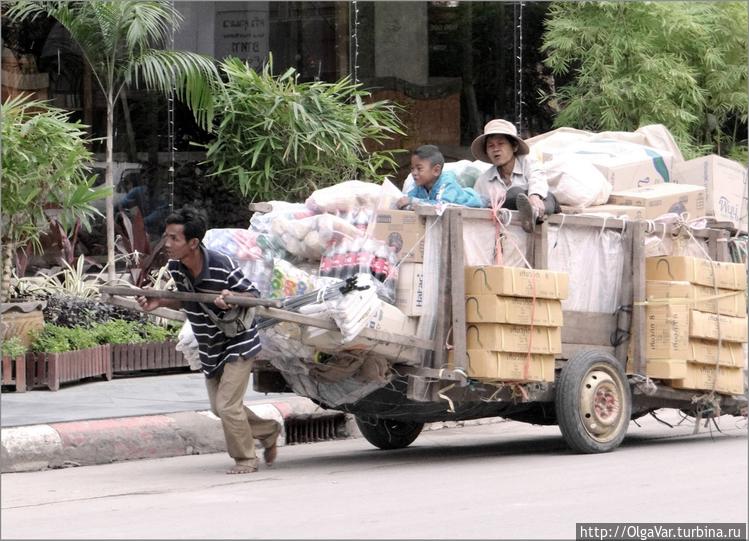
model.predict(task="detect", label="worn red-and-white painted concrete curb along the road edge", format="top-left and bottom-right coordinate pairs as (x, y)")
top-left (0, 397), bottom-right (502, 473)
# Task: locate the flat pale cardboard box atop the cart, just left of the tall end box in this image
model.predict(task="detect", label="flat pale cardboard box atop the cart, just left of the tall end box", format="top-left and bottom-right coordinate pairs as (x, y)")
top-left (608, 184), bottom-right (705, 220)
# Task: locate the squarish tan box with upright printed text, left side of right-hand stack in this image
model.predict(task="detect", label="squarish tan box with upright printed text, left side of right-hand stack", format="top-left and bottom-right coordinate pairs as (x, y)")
top-left (645, 305), bottom-right (689, 360)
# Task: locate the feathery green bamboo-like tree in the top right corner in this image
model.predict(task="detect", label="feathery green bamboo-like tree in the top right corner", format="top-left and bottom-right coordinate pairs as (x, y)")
top-left (542, 2), bottom-right (747, 154)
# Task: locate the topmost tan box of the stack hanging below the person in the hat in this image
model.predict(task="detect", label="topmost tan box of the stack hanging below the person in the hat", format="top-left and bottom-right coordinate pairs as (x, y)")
top-left (465, 265), bottom-right (569, 299)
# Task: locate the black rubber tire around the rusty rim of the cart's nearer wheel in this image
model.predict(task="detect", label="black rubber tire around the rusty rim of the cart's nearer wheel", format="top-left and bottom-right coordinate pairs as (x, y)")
top-left (554, 350), bottom-right (632, 454)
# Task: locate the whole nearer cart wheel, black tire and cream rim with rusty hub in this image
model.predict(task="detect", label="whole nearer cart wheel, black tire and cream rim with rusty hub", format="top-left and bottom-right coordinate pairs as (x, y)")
top-left (555, 350), bottom-right (632, 453)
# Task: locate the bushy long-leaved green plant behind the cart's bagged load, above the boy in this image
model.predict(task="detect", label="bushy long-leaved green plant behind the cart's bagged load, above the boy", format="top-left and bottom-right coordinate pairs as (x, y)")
top-left (206, 58), bottom-right (403, 199)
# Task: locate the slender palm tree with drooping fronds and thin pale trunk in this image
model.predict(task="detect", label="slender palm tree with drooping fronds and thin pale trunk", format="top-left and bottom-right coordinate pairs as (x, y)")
top-left (8, 0), bottom-right (220, 281)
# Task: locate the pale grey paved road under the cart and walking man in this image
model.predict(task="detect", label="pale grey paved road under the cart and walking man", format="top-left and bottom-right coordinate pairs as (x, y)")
top-left (1, 412), bottom-right (747, 539)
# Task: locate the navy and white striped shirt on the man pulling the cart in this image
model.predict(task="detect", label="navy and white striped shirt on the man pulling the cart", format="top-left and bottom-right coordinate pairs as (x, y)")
top-left (167, 243), bottom-right (260, 378)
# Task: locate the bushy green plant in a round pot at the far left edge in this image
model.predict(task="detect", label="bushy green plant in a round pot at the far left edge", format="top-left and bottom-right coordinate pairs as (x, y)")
top-left (0, 95), bottom-right (108, 345)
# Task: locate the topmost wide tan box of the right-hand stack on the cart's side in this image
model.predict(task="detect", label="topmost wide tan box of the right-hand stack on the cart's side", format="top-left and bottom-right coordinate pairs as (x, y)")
top-left (645, 256), bottom-right (746, 291)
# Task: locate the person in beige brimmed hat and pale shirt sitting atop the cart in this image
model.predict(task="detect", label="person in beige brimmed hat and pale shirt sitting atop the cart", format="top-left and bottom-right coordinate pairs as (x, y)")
top-left (471, 119), bottom-right (560, 233)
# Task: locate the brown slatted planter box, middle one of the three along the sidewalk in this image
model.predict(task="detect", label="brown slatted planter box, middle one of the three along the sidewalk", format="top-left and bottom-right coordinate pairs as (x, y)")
top-left (26, 344), bottom-right (112, 391)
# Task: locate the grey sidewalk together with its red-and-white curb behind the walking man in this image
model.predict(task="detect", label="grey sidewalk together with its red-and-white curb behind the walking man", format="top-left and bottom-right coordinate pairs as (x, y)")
top-left (0, 372), bottom-right (325, 472)
